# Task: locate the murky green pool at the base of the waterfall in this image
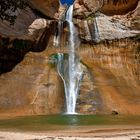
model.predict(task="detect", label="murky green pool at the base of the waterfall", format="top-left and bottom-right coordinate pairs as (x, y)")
top-left (0, 115), bottom-right (140, 131)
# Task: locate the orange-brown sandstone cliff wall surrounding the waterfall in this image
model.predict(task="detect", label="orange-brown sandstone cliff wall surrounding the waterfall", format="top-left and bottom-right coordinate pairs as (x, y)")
top-left (0, 0), bottom-right (140, 115)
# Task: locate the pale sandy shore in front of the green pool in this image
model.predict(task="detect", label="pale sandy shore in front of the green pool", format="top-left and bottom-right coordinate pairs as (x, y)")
top-left (0, 127), bottom-right (140, 140)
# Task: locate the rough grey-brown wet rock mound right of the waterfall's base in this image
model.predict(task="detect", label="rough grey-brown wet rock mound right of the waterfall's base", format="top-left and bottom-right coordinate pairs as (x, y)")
top-left (76, 69), bottom-right (103, 114)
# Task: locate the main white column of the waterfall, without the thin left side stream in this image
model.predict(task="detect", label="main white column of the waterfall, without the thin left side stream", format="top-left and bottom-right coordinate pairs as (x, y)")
top-left (66, 5), bottom-right (82, 114)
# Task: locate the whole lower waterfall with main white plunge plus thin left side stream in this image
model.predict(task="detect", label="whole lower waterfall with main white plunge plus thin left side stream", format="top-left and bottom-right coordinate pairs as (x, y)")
top-left (53, 5), bottom-right (84, 114)
